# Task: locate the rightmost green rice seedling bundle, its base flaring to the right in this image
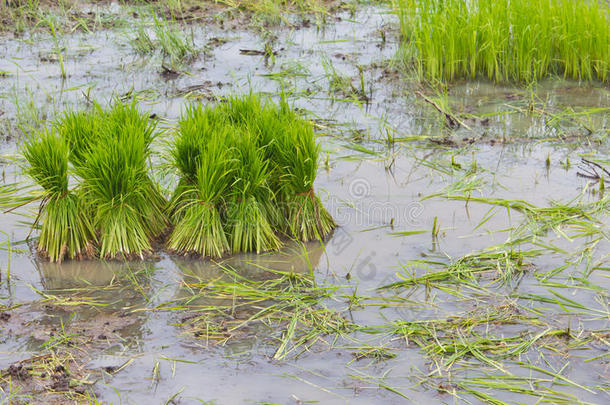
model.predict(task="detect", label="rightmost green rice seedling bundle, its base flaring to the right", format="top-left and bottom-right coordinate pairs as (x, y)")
top-left (221, 94), bottom-right (336, 241)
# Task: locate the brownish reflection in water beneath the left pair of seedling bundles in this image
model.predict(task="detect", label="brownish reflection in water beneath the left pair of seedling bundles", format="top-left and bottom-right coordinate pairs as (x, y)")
top-left (17, 258), bottom-right (157, 352)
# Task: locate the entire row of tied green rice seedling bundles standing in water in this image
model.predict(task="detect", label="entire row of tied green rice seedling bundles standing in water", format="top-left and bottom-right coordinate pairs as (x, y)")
top-left (22, 94), bottom-right (336, 261)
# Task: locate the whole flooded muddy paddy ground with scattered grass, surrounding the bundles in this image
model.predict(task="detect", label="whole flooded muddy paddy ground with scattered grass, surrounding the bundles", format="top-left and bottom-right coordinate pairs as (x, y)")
top-left (0, 6), bottom-right (610, 404)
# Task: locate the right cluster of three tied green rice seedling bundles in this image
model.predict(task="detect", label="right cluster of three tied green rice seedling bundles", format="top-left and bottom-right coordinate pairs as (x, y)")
top-left (168, 94), bottom-right (335, 257)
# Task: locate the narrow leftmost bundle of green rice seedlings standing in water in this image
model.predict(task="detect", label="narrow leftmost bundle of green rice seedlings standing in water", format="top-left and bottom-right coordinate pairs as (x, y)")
top-left (23, 130), bottom-right (95, 262)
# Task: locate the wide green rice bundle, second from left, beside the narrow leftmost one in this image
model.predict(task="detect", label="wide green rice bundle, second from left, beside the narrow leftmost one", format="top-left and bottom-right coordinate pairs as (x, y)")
top-left (68, 100), bottom-right (168, 258)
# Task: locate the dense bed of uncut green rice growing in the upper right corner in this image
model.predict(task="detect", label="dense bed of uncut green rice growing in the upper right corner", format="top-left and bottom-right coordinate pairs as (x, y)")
top-left (398, 0), bottom-right (610, 82)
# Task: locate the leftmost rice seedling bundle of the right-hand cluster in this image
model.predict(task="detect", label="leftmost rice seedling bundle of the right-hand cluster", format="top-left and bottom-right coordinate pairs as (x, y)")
top-left (168, 106), bottom-right (233, 257)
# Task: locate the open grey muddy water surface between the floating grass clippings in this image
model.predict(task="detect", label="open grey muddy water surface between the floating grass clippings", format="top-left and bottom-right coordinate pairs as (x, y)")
top-left (0, 3), bottom-right (610, 404)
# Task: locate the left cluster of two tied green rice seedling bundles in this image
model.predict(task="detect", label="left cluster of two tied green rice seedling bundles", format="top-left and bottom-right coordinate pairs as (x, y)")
top-left (23, 101), bottom-right (168, 261)
